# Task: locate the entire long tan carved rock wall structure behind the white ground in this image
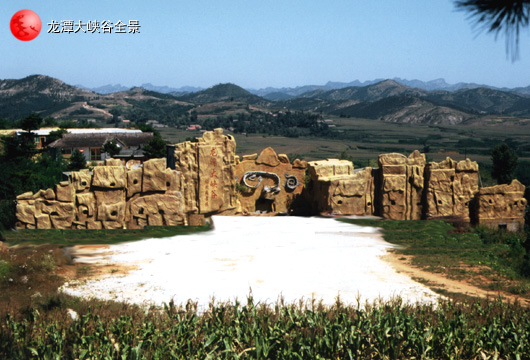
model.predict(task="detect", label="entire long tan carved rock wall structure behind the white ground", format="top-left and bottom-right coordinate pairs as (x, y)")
top-left (16, 129), bottom-right (527, 231)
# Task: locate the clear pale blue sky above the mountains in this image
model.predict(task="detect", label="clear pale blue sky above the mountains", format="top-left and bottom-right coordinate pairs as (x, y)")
top-left (0, 0), bottom-right (530, 89)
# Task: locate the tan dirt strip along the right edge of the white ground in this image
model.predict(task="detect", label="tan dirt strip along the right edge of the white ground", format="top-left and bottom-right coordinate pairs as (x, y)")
top-left (383, 250), bottom-right (530, 307)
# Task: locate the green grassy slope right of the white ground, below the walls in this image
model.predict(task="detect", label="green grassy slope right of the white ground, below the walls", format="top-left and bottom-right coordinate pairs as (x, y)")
top-left (340, 219), bottom-right (530, 297)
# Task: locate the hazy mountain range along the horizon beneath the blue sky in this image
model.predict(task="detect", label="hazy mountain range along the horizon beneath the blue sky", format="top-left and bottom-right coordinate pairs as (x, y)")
top-left (0, 75), bottom-right (530, 126)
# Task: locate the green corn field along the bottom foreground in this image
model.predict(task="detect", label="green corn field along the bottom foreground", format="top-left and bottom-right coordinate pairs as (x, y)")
top-left (0, 297), bottom-right (530, 359)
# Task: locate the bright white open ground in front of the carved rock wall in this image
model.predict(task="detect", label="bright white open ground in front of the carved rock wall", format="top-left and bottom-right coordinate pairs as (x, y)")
top-left (62, 216), bottom-right (439, 309)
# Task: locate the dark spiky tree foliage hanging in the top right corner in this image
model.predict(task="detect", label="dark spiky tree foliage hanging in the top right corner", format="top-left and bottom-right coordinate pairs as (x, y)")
top-left (455, 0), bottom-right (530, 60)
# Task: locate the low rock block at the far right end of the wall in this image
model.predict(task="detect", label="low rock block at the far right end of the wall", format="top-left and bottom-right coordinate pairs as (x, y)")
top-left (475, 180), bottom-right (527, 231)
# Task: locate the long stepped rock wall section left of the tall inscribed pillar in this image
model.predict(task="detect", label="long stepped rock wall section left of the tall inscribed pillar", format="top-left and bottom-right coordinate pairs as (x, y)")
top-left (17, 159), bottom-right (187, 229)
